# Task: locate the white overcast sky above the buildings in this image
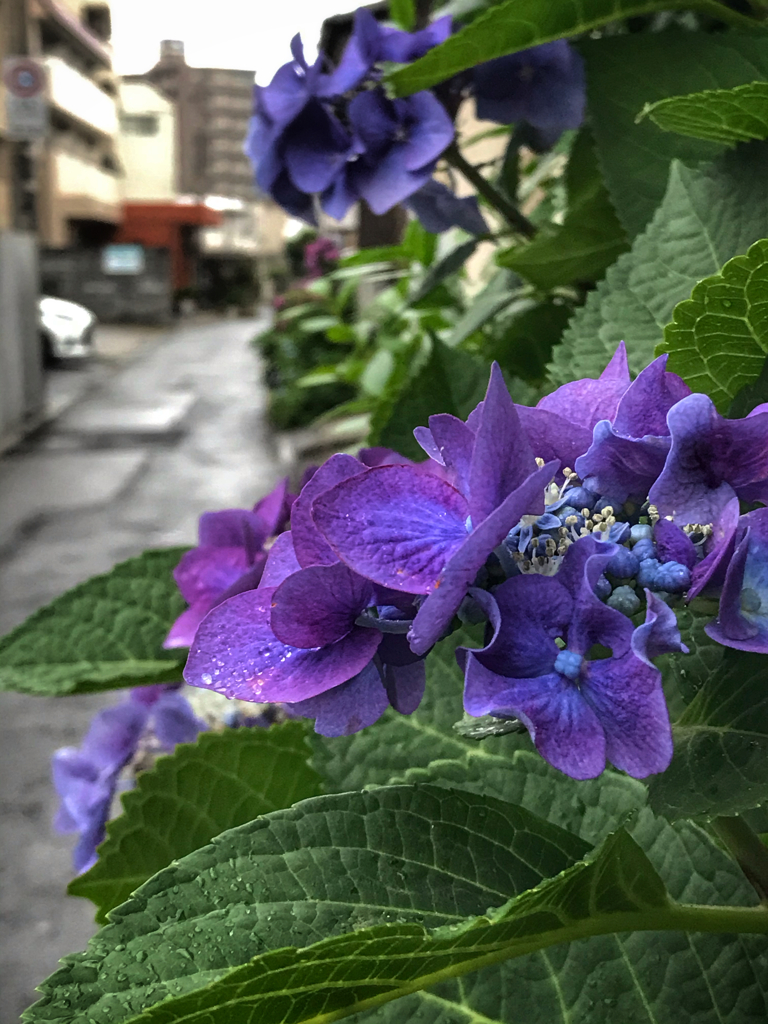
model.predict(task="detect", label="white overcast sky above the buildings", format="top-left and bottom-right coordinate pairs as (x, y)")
top-left (112, 0), bottom-right (358, 85)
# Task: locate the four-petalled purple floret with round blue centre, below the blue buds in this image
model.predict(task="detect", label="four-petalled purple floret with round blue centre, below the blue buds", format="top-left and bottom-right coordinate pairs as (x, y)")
top-left (461, 537), bottom-right (685, 778)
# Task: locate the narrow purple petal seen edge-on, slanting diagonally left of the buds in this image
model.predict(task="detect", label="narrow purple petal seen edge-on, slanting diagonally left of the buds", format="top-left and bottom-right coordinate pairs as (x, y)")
top-left (408, 463), bottom-right (557, 654)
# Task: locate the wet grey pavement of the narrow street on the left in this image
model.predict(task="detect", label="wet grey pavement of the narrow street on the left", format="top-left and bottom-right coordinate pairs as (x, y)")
top-left (0, 319), bottom-right (286, 1024)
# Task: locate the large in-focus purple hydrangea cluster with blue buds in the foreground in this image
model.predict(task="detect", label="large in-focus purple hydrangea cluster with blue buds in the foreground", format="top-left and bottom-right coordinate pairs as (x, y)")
top-left (184, 344), bottom-right (768, 778)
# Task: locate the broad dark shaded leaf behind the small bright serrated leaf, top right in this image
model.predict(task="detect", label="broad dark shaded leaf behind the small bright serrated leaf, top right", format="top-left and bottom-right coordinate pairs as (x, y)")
top-left (578, 32), bottom-right (768, 237)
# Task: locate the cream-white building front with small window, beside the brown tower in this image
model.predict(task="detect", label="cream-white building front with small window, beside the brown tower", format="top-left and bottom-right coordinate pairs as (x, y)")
top-left (118, 82), bottom-right (177, 203)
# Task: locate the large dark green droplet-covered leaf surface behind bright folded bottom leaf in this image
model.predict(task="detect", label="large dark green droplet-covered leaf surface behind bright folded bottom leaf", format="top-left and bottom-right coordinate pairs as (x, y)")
top-left (22, 785), bottom-right (588, 1024)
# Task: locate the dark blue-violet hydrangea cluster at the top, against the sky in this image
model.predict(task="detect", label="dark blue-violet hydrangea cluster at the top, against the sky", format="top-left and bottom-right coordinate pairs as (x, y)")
top-left (245, 7), bottom-right (585, 234)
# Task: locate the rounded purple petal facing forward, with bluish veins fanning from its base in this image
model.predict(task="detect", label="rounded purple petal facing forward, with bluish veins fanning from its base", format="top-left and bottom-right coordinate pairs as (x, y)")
top-left (312, 466), bottom-right (468, 594)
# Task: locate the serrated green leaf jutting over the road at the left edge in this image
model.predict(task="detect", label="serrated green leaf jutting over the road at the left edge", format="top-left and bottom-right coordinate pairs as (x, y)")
top-left (0, 548), bottom-right (186, 696)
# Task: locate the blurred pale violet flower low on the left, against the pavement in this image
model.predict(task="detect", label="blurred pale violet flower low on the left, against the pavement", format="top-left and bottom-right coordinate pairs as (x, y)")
top-left (51, 686), bottom-right (207, 874)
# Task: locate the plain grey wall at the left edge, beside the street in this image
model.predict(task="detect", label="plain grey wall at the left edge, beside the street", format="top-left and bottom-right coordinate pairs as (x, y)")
top-left (0, 231), bottom-right (43, 449)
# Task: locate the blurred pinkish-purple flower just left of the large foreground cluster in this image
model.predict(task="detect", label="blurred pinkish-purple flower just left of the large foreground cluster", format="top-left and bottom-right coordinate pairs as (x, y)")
top-left (163, 478), bottom-right (293, 648)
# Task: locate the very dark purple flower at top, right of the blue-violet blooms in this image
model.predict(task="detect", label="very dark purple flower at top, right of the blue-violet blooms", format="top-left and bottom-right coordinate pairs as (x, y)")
top-left (472, 39), bottom-right (586, 141)
